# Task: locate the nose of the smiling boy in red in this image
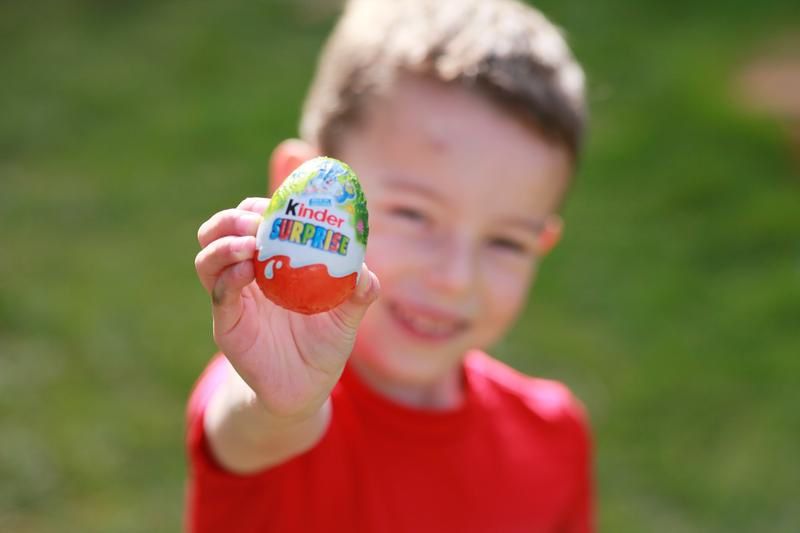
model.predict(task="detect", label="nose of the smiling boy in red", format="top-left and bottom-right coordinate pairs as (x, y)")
top-left (427, 236), bottom-right (478, 296)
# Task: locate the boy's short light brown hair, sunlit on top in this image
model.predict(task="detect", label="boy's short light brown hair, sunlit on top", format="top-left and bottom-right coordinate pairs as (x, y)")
top-left (300, 0), bottom-right (586, 159)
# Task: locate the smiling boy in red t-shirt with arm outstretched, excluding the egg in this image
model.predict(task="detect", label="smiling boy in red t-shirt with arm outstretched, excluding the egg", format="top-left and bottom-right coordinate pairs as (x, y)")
top-left (187, 0), bottom-right (593, 533)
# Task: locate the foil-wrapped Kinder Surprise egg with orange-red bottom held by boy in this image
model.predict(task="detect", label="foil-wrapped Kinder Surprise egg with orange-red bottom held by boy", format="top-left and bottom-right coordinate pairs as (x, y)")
top-left (254, 157), bottom-right (369, 314)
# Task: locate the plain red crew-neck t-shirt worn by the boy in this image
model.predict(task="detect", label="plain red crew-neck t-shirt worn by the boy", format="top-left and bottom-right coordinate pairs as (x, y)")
top-left (186, 351), bottom-right (594, 533)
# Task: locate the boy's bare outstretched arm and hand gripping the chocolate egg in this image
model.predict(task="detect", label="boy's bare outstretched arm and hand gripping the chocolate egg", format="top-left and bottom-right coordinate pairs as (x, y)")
top-left (195, 198), bottom-right (379, 474)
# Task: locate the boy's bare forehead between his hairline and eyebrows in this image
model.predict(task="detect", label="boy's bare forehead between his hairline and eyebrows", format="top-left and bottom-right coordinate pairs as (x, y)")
top-left (341, 76), bottom-right (570, 215)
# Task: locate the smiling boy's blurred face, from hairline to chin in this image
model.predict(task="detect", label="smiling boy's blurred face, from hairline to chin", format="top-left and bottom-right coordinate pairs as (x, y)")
top-left (337, 77), bottom-right (571, 384)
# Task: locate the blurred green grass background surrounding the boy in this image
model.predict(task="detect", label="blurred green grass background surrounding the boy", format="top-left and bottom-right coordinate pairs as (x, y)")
top-left (0, 0), bottom-right (800, 533)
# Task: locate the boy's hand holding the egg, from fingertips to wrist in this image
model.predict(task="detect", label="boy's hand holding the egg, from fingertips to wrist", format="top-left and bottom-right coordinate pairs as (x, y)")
top-left (195, 198), bottom-right (380, 418)
